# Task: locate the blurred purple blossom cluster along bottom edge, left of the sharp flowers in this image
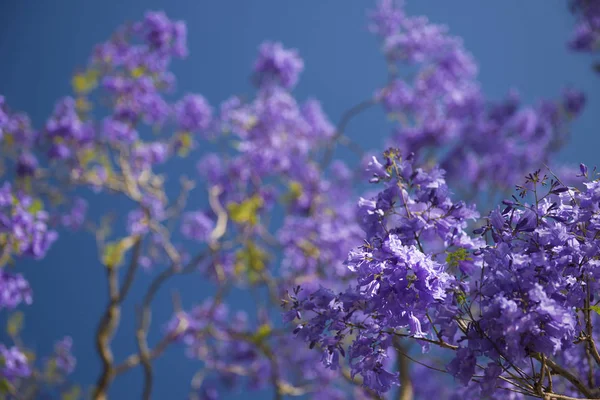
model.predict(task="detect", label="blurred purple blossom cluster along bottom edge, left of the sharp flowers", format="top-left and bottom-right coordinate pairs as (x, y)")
top-left (166, 301), bottom-right (358, 398)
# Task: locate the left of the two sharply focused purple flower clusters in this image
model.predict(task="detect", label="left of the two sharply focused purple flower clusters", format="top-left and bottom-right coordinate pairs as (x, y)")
top-left (285, 149), bottom-right (480, 391)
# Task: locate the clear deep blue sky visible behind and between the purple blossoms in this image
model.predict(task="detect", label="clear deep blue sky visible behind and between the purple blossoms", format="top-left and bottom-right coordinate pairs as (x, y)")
top-left (0, 0), bottom-right (600, 399)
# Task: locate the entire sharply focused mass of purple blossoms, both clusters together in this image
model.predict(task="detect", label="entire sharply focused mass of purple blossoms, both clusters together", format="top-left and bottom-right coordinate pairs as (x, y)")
top-left (284, 156), bottom-right (600, 399)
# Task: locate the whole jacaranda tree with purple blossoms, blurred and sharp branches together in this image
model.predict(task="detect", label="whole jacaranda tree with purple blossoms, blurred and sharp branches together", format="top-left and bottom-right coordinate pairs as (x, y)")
top-left (0, 0), bottom-right (600, 400)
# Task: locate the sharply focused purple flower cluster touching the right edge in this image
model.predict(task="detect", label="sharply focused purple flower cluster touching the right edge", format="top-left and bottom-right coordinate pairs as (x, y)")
top-left (450, 165), bottom-right (600, 394)
